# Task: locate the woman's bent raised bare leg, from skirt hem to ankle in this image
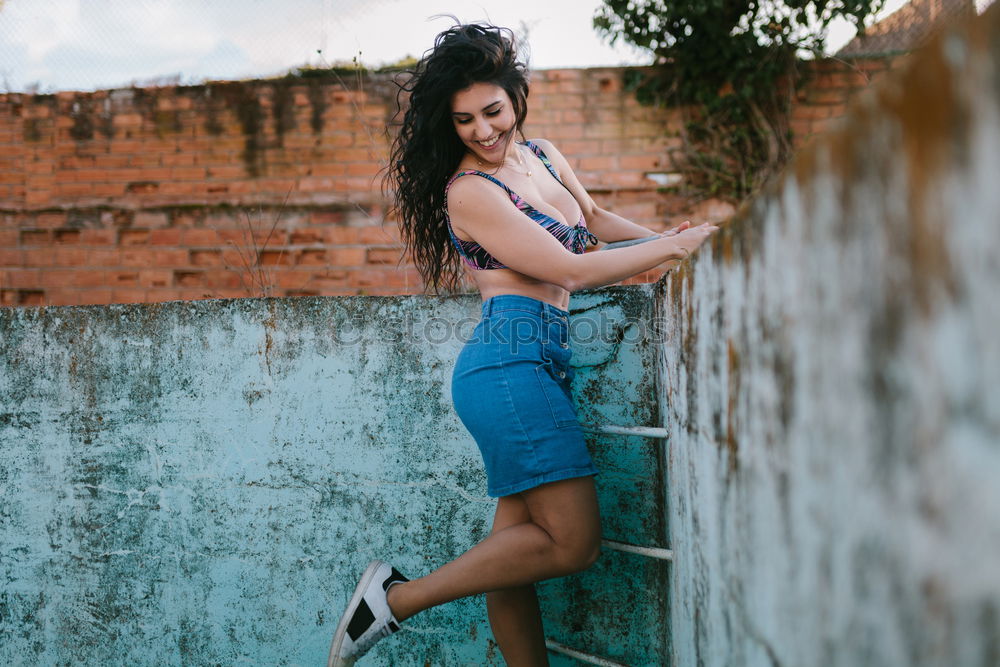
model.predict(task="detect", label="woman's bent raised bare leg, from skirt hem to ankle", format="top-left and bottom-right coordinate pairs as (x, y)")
top-left (388, 476), bottom-right (601, 621)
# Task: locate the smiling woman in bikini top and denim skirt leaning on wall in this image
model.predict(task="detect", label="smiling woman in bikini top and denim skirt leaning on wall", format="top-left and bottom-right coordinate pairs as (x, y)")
top-left (330, 20), bottom-right (717, 665)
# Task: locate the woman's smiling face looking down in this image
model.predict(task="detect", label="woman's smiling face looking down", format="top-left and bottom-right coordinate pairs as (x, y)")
top-left (451, 83), bottom-right (517, 164)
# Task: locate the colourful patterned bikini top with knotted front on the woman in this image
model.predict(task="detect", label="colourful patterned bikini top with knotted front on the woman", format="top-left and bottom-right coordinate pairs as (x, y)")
top-left (444, 141), bottom-right (597, 270)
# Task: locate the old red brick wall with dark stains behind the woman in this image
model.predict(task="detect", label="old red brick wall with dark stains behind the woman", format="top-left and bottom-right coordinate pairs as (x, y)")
top-left (0, 61), bottom-right (900, 305)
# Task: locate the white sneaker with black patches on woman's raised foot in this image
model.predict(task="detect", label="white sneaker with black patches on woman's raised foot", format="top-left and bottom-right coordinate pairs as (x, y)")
top-left (326, 560), bottom-right (409, 667)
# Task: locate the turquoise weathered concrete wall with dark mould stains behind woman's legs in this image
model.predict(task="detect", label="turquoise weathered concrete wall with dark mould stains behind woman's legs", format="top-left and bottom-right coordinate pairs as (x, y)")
top-left (0, 287), bottom-right (668, 666)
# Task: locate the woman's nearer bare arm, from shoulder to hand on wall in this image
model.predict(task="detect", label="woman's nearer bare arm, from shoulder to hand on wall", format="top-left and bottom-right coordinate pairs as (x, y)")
top-left (448, 178), bottom-right (718, 292)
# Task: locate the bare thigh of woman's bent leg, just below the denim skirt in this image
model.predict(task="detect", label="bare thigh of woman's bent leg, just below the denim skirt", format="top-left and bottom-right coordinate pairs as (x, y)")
top-left (519, 476), bottom-right (601, 544)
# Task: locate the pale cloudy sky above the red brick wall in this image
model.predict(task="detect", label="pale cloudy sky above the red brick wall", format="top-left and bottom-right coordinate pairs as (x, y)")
top-left (0, 0), bottom-right (984, 92)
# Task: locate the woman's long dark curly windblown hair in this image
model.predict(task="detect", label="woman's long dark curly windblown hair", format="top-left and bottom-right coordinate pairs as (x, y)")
top-left (383, 23), bottom-right (528, 293)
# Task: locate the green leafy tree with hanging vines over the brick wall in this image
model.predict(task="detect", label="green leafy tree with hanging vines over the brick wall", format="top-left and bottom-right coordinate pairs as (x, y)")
top-left (594, 0), bottom-right (884, 200)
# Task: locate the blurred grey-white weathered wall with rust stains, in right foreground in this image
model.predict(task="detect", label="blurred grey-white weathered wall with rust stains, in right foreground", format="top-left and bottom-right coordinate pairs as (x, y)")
top-left (660, 7), bottom-right (1000, 667)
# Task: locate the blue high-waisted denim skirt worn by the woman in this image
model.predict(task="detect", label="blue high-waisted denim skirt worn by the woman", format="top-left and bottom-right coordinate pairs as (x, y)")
top-left (451, 294), bottom-right (597, 497)
